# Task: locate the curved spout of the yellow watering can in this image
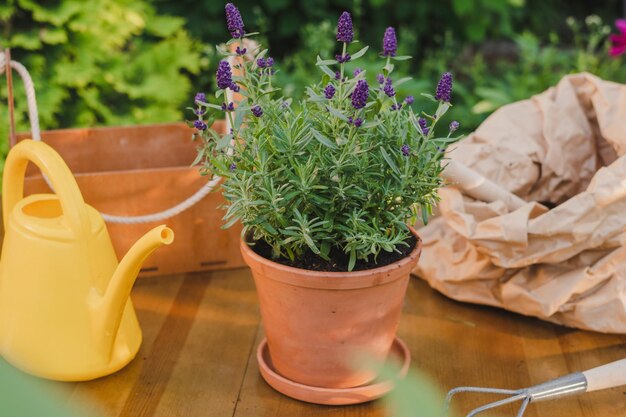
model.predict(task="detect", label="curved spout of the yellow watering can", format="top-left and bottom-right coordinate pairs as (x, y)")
top-left (96, 225), bottom-right (174, 354)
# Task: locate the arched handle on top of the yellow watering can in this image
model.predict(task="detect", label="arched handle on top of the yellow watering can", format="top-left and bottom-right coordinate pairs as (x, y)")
top-left (2, 139), bottom-right (90, 235)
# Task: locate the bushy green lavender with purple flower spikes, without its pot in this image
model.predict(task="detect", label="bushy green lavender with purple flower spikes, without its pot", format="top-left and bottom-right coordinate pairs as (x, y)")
top-left (190, 3), bottom-right (459, 270)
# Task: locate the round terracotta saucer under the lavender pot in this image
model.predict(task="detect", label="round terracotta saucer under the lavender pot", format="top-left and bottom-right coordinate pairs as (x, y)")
top-left (256, 337), bottom-right (411, 405)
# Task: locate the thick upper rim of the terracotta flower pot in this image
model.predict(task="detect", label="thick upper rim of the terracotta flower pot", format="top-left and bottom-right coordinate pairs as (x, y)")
top-left (240, 226), bottom-right (422, 289)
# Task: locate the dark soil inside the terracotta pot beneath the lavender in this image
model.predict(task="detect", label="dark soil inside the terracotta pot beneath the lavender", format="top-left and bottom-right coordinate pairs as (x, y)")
top-left (250, 235), bottom-right (417, 272)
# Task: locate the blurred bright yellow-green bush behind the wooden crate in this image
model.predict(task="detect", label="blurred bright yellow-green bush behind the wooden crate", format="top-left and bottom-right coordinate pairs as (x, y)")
top-left (0, 0), bottom-right (201, 174)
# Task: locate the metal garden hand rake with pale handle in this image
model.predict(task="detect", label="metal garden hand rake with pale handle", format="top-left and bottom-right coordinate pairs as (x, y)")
top-left (444, 359), bottom-right (626, 417)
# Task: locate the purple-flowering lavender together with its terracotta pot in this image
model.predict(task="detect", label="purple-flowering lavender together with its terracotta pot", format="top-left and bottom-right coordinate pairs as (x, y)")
top-left (190, 3), bottom-right (459, 400)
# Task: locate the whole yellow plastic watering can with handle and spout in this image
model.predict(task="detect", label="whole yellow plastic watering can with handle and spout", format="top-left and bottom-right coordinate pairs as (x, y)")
top-left (0, 140), bottom-right (174, 381)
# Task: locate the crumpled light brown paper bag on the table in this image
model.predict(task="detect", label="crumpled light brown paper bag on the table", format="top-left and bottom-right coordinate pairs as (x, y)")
top-left (414, 74), bottom-right (626, 333)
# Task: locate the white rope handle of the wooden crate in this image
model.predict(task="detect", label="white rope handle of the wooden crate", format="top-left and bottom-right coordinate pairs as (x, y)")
top-left (0, 52), bottom-right (224, 224)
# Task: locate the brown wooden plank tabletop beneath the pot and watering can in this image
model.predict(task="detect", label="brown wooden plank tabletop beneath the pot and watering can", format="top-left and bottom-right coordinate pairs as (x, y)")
top-left (41, 269), bottom-right (626, 417)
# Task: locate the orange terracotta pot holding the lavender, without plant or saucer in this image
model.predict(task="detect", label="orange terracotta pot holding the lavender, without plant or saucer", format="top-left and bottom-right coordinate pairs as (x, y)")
top-left (241, 229), bottom-right (422, 388)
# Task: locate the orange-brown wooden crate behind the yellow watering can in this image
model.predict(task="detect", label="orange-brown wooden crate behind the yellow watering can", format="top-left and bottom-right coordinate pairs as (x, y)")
top-left (18, 122), bottom-right (244, 276)
